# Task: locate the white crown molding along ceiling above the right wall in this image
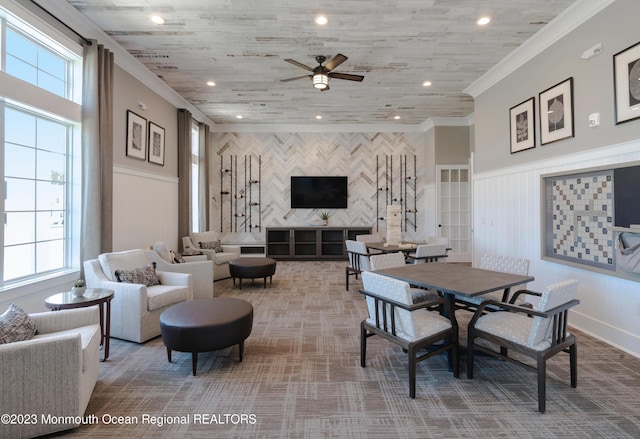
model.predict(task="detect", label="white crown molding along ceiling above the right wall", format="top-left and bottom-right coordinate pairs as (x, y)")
top-left (463, 0), bottom-right (615, 99)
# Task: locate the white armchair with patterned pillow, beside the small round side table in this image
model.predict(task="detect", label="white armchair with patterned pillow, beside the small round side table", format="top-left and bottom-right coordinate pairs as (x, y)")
top-left (84, 249), bottom-right (193, 343)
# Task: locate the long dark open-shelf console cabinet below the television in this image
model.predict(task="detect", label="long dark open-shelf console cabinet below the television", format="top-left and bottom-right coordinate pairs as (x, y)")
top-left (267, 226), bottom-right (371, 261)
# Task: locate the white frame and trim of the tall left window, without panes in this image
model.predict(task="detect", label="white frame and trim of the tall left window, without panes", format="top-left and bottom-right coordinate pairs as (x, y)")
top-left (0, 1), bottom-right (82, 303)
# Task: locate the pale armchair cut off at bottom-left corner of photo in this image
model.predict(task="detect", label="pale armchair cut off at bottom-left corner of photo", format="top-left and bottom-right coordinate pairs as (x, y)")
top-left (0, 306), bottom-right (100, 438)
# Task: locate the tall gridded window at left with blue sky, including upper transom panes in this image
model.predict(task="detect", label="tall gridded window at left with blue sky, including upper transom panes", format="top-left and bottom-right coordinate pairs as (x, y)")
top-left (0, 8), bottom-right (81, 288)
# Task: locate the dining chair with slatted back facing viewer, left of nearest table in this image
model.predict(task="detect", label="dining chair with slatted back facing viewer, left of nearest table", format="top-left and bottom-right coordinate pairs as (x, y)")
top-left (360, 272), bottom-right (459, 399)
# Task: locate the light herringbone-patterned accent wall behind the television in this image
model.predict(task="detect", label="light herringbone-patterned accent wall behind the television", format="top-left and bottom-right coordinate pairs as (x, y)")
top-left (210, 133), bottom-right (425, 241)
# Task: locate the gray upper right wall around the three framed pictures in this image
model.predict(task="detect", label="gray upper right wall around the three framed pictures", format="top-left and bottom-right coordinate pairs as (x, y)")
top-left (475, 0), bottom-right (640, 172)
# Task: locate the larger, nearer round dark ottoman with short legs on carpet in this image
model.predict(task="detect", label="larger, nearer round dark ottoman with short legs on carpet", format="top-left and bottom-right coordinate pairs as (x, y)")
top-left (160, 297), bottom-right (253, 376)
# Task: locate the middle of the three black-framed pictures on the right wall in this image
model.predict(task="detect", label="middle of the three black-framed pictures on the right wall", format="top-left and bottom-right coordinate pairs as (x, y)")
top-left (538, 78), bottom-right (574, 145)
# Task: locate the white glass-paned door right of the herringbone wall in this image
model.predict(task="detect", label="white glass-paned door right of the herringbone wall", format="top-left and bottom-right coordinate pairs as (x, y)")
top-left (436, 165), bottom-right (471, 262)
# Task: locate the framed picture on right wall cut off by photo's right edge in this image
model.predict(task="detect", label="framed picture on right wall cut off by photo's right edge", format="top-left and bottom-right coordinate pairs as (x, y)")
top-left (613, 43), bottom-right (640, 125)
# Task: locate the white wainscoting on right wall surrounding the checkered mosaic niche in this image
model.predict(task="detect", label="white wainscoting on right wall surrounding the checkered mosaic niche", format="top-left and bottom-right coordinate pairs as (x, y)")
top-left (473, 141), bottom-right (640, 357)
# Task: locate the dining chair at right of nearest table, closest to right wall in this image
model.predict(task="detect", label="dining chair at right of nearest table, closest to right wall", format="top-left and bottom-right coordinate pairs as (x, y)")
top-left (467, 279), bottom-right (580, 413)
